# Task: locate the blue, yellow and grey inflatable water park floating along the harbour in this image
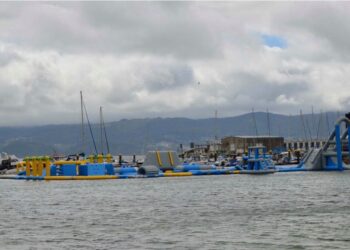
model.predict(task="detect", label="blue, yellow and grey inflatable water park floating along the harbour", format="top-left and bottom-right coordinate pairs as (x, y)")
top-left (0, 117), bottom-right (350, 181)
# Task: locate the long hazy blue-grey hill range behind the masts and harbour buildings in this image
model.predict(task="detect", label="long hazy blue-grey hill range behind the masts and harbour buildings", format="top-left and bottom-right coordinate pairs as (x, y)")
top-left (0, 112), bottom-right (344, 156)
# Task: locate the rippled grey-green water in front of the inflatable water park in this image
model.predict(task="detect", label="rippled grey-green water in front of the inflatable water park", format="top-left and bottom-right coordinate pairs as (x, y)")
top-left (0, 171), bottom-right (350, 249)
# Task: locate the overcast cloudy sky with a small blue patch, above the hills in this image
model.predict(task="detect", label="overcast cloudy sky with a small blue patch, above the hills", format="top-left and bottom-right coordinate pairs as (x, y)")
top-left (0, 2), bottom-right (350, 126)
